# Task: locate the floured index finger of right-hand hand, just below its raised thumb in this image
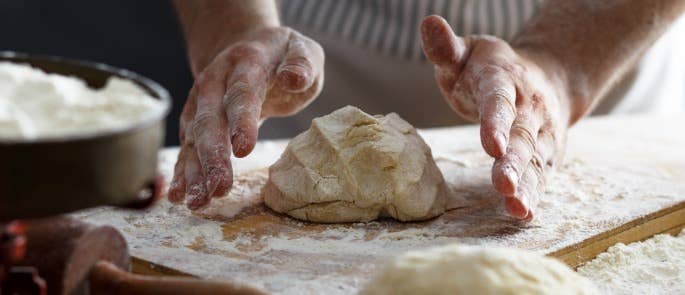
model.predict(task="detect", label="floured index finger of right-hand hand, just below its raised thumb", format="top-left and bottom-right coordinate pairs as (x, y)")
top-left (475, 71), bottom-right (516, 159)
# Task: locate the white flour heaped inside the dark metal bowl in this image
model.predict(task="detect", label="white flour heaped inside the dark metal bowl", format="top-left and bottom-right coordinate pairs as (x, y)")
top-left (0, 62), bottom-right (164, 140)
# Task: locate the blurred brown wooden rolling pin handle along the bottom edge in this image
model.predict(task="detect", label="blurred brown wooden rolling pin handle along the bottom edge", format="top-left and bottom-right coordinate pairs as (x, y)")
top-left (89, 261), bottom-right (268, 295)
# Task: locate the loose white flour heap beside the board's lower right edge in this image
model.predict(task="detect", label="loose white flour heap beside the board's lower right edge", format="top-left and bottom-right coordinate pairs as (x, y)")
top-left (578, 231), bottom-right (685, 294)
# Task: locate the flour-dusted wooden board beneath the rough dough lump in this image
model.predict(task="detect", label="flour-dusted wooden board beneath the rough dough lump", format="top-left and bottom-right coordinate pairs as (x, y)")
top-left (76, 116), bottom-right (685, 294)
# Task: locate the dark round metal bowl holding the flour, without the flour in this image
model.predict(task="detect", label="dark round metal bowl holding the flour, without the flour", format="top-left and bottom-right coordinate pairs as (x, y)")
top-left (0, 52), bottom-right (171, 222)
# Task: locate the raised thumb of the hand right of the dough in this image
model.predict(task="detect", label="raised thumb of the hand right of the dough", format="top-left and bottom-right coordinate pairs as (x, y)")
top-left (421, 15), bottom-right (466, 69)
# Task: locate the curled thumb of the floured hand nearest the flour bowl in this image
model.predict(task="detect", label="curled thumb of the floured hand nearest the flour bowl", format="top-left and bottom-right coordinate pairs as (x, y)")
top-left (276, 32), bottom-right (324, 93)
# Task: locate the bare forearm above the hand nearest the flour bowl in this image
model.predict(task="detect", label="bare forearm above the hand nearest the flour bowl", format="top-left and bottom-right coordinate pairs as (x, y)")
top-left (173, 0), bottom-right (279, 74)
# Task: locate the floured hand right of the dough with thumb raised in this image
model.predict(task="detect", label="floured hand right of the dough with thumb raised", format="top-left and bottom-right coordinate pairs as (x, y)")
top-left (421, 16), bottom-right (575, 220)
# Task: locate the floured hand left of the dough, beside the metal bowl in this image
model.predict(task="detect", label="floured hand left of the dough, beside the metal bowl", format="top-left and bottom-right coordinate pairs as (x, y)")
top-left (169, 27), bottom-right (324, 210)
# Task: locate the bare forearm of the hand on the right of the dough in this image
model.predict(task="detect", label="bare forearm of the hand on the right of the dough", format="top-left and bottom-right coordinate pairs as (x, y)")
top-left (512, 0), bottom-right (685, 124)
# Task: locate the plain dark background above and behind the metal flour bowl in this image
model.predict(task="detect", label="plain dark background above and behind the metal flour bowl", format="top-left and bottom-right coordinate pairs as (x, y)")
top-left (0, 0), bottom-right (192, 145)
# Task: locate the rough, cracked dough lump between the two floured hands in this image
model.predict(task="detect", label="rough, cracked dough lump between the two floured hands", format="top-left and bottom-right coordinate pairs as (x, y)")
top-left (262, 106), bottom-right (447, 223)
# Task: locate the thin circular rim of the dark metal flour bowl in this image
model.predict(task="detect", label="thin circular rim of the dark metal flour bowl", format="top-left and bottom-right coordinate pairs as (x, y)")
top-left (0, 50), bottom-right (171, 146)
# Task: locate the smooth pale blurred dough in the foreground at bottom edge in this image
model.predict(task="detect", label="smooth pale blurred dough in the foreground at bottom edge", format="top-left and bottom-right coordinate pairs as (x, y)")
top-left (360, 244), bottom-right (599, 295)
